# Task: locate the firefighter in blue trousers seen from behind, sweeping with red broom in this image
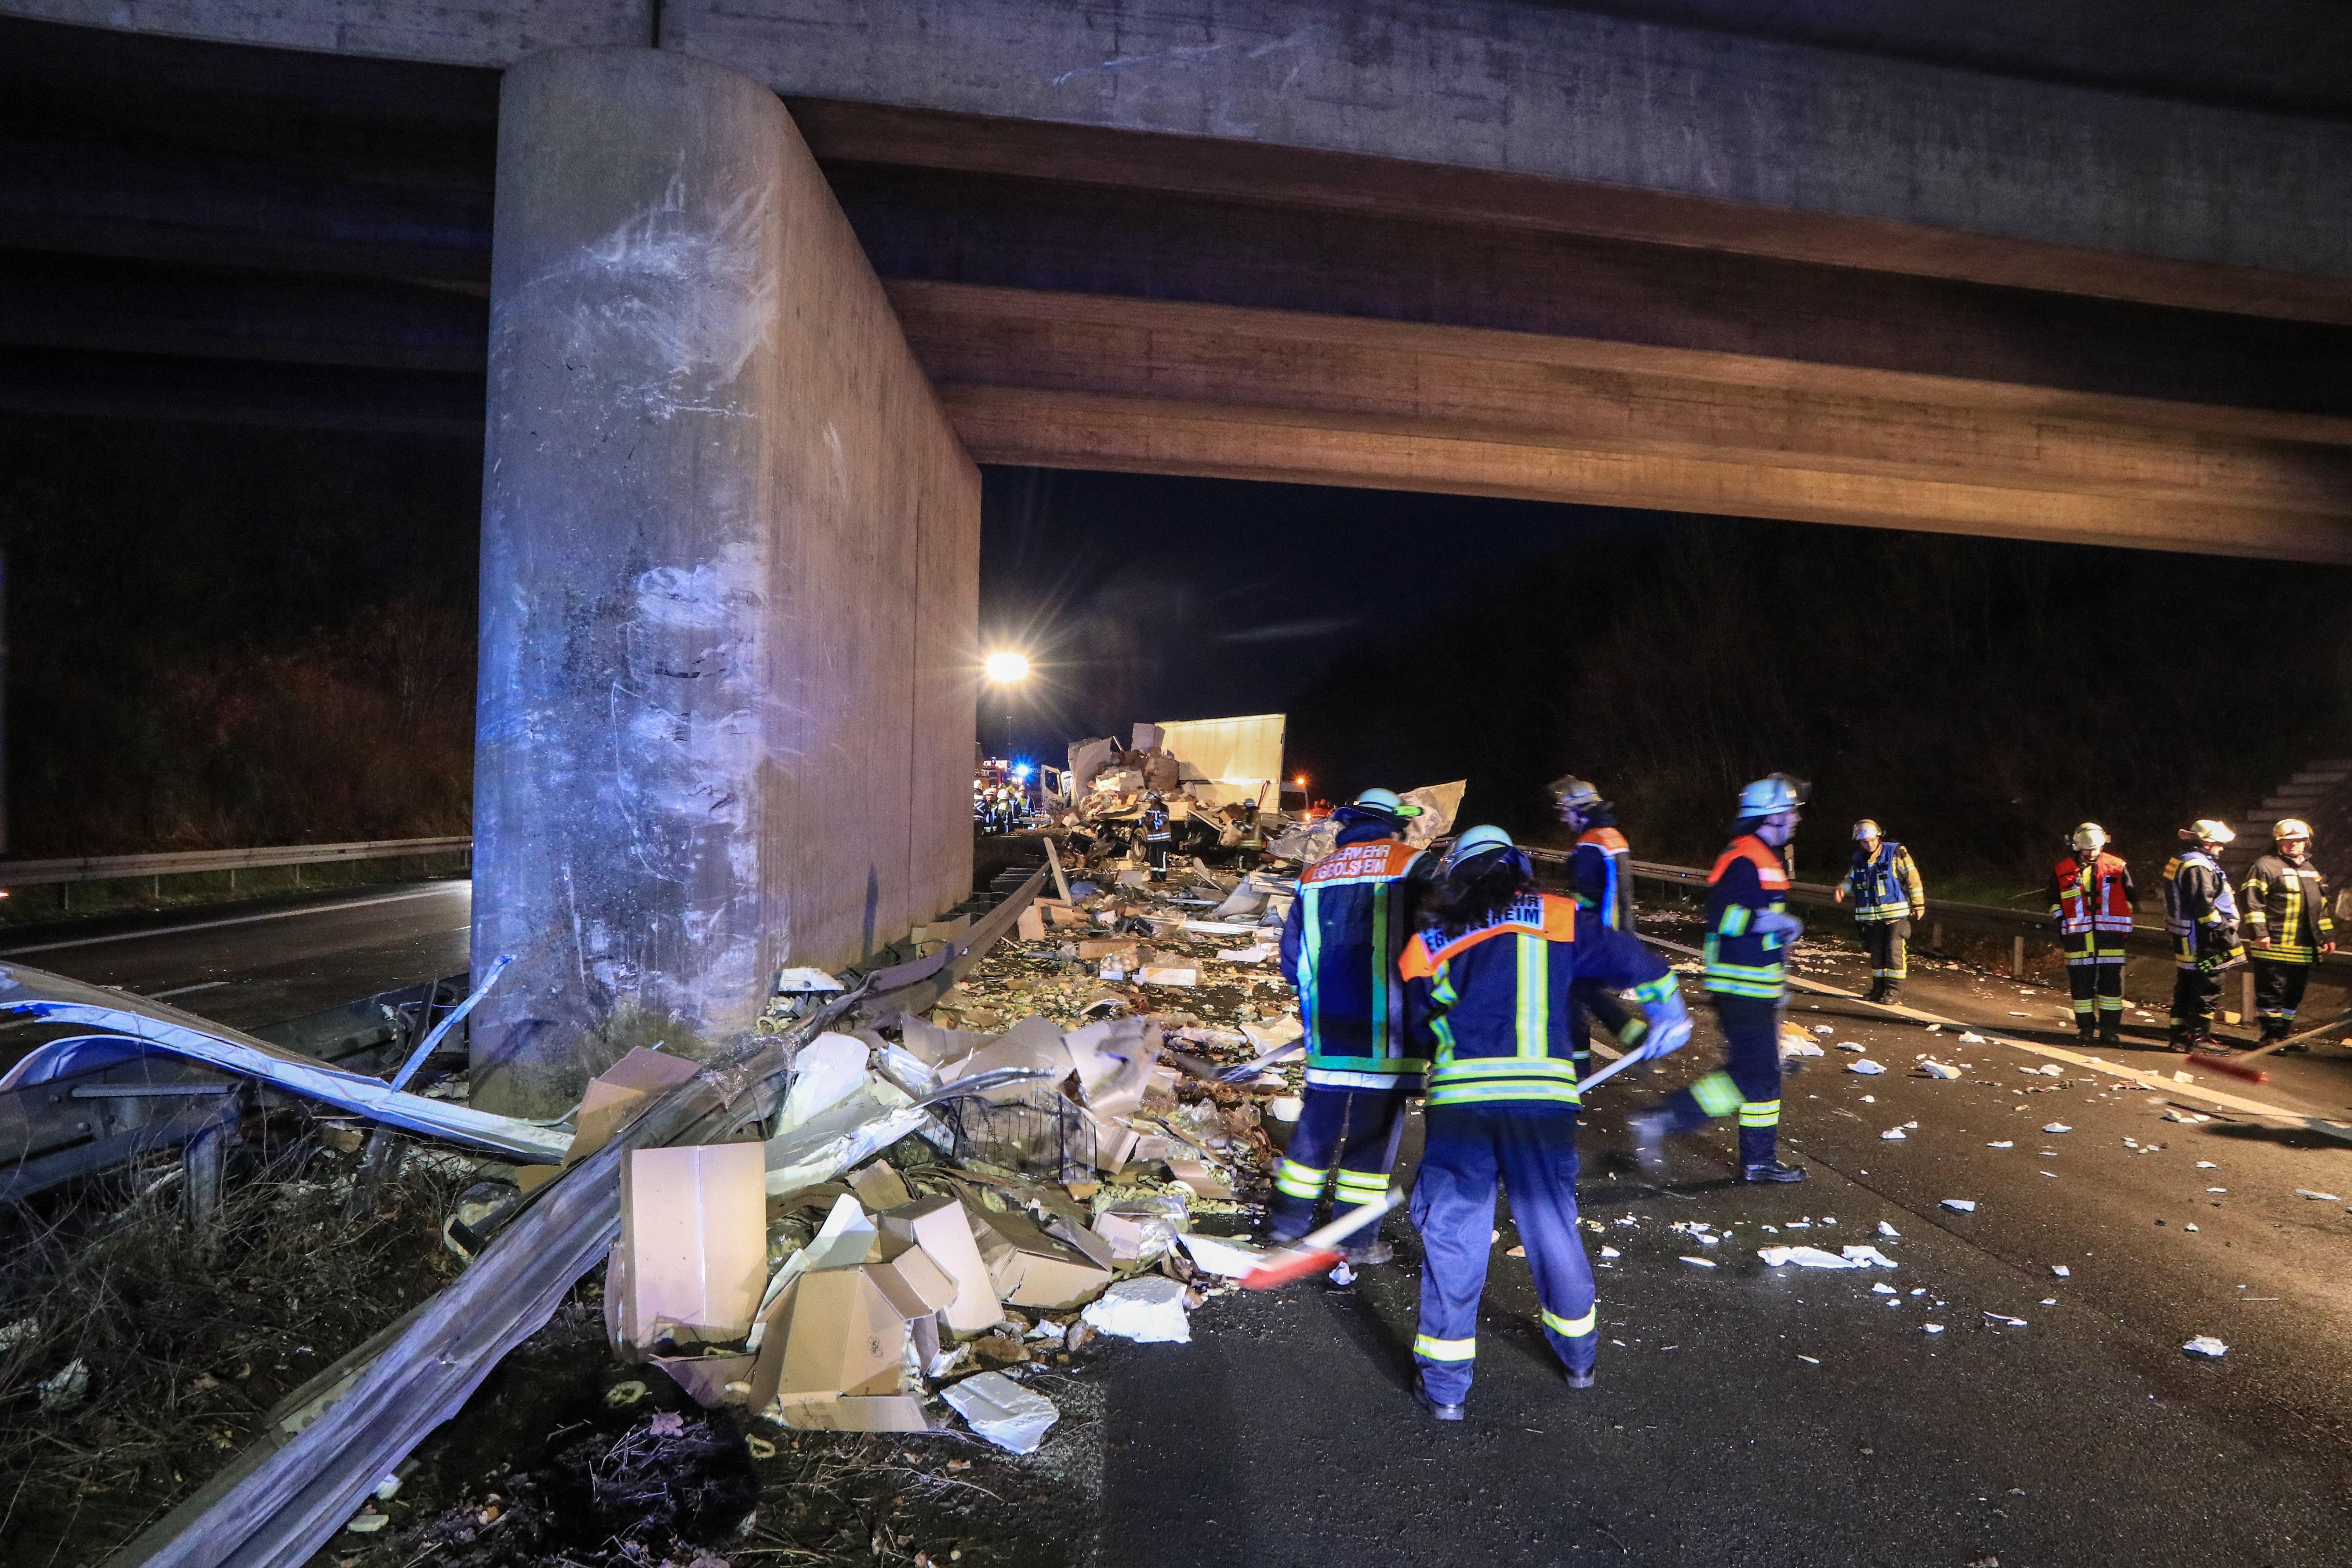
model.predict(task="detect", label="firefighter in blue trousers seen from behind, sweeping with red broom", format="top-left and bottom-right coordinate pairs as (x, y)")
top-left (1399, 828), bottom-right (1691, 1420)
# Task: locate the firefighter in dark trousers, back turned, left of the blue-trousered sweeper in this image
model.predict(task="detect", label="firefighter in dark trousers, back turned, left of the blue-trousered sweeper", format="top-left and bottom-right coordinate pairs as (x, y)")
top-left (1268, 790), bottom-right (1428, 1262)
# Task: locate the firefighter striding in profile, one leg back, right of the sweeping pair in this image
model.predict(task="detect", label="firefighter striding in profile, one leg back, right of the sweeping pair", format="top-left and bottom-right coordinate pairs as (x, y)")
top-left (1625, 773), bottom-right (1806, 1182)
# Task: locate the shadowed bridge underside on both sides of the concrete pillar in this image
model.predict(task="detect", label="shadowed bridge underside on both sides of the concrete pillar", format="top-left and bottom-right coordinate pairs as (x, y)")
top-left (0, 21), bottom-right (2352, 562)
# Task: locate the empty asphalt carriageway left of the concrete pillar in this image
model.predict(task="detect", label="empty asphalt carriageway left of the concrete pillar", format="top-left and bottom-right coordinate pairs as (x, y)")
top-left (0, 879), bottom-right (473, 1030)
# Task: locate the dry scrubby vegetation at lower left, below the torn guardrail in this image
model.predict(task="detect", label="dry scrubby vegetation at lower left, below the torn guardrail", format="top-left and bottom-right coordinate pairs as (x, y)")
top-left (0, 1138), bottom-right (473, 1568)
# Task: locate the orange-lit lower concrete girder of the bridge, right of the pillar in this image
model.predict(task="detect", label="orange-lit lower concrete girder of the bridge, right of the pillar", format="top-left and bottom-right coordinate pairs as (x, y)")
top-left (891, 282), bottom-right (2352, 562)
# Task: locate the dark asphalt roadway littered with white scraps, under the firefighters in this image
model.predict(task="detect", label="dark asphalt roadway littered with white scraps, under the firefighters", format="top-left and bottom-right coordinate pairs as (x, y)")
top-left (1103, 929), bottom-right (2352, 1568)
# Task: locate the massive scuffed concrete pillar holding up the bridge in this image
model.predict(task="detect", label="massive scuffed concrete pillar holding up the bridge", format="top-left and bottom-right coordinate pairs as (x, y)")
top-left (473, 49), bottom-right (978, 1114)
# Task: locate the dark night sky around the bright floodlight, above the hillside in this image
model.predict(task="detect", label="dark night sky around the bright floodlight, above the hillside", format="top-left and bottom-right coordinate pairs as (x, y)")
top-left (981, 468), bottom-right (1658, 762)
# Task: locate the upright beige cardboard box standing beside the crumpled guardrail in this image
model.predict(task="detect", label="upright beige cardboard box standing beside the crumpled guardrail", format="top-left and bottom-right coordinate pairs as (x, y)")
top-left (619, 1143), bottom-right (767, 1352)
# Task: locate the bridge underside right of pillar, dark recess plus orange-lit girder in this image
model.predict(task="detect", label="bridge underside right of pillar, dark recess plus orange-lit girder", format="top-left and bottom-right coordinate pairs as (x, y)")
top-left (793, 103), bottom-right (2352, 562)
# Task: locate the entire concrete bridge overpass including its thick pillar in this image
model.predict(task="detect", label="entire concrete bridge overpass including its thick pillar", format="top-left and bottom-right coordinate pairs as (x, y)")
top-left (0, 0), bottom-right (2352, 1100)
